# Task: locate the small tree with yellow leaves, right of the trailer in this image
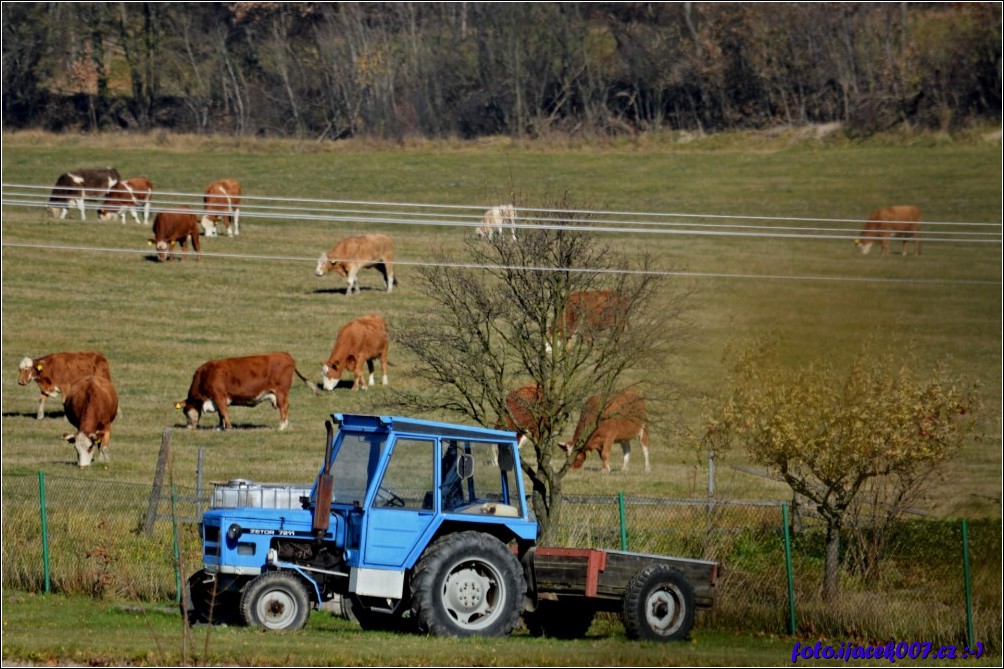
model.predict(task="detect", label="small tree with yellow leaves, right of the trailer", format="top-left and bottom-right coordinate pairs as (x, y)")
top-left (702, 339), bottom-right (978, 601)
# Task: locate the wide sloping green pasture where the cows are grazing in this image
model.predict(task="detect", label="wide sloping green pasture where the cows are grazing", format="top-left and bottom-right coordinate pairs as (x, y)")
top-left (2, 134), bottom-right (1002, 515)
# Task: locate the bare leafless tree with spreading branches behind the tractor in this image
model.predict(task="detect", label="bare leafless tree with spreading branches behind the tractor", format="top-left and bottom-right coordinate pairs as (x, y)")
top-left (396, 195), bottom-right (688, 541)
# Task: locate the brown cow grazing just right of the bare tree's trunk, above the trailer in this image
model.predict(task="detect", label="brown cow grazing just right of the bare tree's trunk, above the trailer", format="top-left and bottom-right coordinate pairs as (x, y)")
top-left (561, 388), bottom-right (649, 472)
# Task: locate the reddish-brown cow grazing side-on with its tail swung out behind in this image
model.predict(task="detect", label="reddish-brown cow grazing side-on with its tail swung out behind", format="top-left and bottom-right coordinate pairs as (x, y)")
top-left (175, 352), bottom-right (317, 430)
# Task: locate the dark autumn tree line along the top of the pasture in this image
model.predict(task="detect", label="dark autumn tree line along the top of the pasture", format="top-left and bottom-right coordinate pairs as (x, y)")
top-left (2, 2), bottom-right (1002, 140)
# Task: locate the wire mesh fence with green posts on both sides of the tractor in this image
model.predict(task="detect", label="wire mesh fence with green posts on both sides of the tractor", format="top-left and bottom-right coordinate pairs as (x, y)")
top-left (2, 474), bottom-right (1002, 648)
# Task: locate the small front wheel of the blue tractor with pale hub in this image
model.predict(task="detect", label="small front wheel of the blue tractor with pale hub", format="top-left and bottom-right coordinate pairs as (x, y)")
top-left (241, 572), bottom-right (310, 630)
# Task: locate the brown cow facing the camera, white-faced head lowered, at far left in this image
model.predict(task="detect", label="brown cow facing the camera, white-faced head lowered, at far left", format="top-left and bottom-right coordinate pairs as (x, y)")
top-left (63, 376), bottom-right (118, 467)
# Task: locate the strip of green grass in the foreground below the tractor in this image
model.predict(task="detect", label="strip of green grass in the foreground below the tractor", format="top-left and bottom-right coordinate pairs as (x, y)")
top-left (3, 592), bottom-right (1000, 667)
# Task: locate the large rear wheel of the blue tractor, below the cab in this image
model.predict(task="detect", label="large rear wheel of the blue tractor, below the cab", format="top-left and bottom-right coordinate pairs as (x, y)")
top-left (412, 531), bottom-right (526, 637)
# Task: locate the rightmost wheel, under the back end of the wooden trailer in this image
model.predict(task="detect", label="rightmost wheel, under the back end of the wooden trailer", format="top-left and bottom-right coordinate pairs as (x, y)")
top-left (621, 565), bottom-right (695, 641)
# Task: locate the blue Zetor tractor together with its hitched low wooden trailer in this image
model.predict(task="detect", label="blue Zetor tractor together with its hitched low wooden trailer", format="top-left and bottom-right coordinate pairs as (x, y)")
top-left (183, 414), bottom-right (720, 641)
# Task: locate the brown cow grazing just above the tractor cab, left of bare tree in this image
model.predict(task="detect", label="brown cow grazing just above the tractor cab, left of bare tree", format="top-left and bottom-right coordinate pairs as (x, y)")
top-left (321, 313), bottom-right (391, 390)
